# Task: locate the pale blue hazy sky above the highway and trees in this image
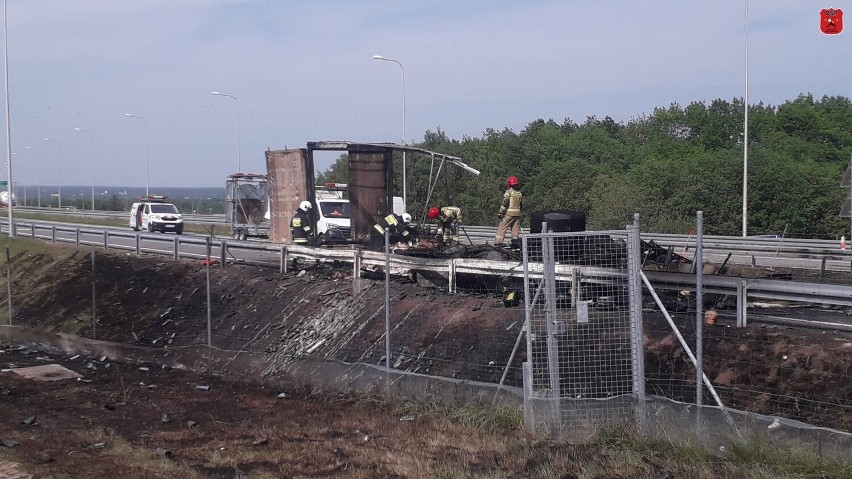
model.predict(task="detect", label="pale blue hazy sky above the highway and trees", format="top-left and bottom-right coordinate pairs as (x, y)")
top-left (0, 0), bottom-right (852, 186)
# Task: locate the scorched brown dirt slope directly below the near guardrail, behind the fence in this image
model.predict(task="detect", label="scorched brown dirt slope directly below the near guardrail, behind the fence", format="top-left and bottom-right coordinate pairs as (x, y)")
top-left (0, 240), bottom-right (852, 431)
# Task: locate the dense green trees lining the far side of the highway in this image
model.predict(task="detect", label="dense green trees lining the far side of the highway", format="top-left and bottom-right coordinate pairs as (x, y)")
top-left (319, 94), bottom-right (852, 238)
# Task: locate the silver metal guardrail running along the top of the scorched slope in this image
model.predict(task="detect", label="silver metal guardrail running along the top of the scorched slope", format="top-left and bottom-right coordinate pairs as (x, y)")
top-left (5, 221), bottom-right (852, 318)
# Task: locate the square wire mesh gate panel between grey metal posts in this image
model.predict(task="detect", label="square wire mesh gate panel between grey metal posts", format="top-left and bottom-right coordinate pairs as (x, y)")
top-left (524, 232), bottom-right (638, 434)
